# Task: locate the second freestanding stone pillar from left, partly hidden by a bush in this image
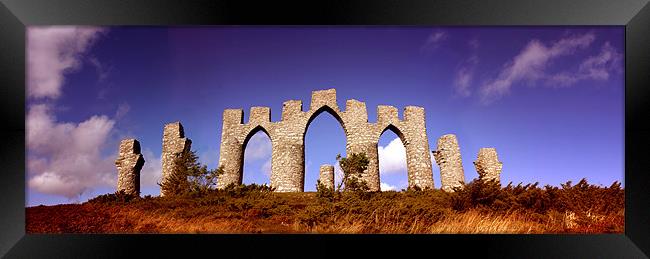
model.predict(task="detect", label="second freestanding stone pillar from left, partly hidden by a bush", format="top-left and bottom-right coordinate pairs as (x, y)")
top-left (160, 122), bottom-right (192, 196)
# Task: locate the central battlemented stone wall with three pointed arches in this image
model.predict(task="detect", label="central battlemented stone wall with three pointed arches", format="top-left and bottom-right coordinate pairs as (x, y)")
top-left (217, 89), bottom-right (434, 192)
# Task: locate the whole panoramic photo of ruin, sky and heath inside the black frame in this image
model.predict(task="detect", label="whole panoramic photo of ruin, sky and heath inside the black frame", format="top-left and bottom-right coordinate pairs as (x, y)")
top-left (25, 26), bottom-right (625, 234)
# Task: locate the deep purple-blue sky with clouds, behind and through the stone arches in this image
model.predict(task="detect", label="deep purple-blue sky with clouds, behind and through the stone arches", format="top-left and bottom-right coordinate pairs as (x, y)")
top-left (25, 26), bottom-right (624, 206)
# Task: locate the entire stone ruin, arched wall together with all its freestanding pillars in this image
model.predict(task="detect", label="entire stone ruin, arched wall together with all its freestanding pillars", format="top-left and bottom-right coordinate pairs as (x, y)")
top-left (116, 89), bottom-right (502, 196)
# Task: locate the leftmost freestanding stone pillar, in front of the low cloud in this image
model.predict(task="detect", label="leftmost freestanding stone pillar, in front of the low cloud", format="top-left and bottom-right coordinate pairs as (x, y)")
top-left (115, 139), bottom-right (144, 196)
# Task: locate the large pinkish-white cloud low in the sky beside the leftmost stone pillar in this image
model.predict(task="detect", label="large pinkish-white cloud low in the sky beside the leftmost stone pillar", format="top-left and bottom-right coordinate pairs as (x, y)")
top-left (26, 104), bottom-right (117, 199)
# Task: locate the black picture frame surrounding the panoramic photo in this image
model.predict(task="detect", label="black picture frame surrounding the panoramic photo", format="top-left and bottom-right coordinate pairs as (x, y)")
top-left (0, 0), bottom-right (650, 258)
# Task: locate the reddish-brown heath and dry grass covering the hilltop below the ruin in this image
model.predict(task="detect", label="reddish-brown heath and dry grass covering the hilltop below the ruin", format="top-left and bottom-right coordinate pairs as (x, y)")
top-left (26, 180), bottom-right (625, 234)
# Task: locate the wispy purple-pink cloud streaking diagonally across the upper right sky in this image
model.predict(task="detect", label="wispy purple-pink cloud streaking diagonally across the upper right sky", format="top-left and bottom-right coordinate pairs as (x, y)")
top-left (480, 33), bottom-right (621, 104)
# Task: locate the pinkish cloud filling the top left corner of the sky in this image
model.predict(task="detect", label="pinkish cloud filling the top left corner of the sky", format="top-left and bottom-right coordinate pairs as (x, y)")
top-left (26, 26), bottom-right (104, 98)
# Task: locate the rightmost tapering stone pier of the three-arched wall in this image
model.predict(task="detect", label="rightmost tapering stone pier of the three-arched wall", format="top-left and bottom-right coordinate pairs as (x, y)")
top-left (403, 106), bottom-right (434, 189)
